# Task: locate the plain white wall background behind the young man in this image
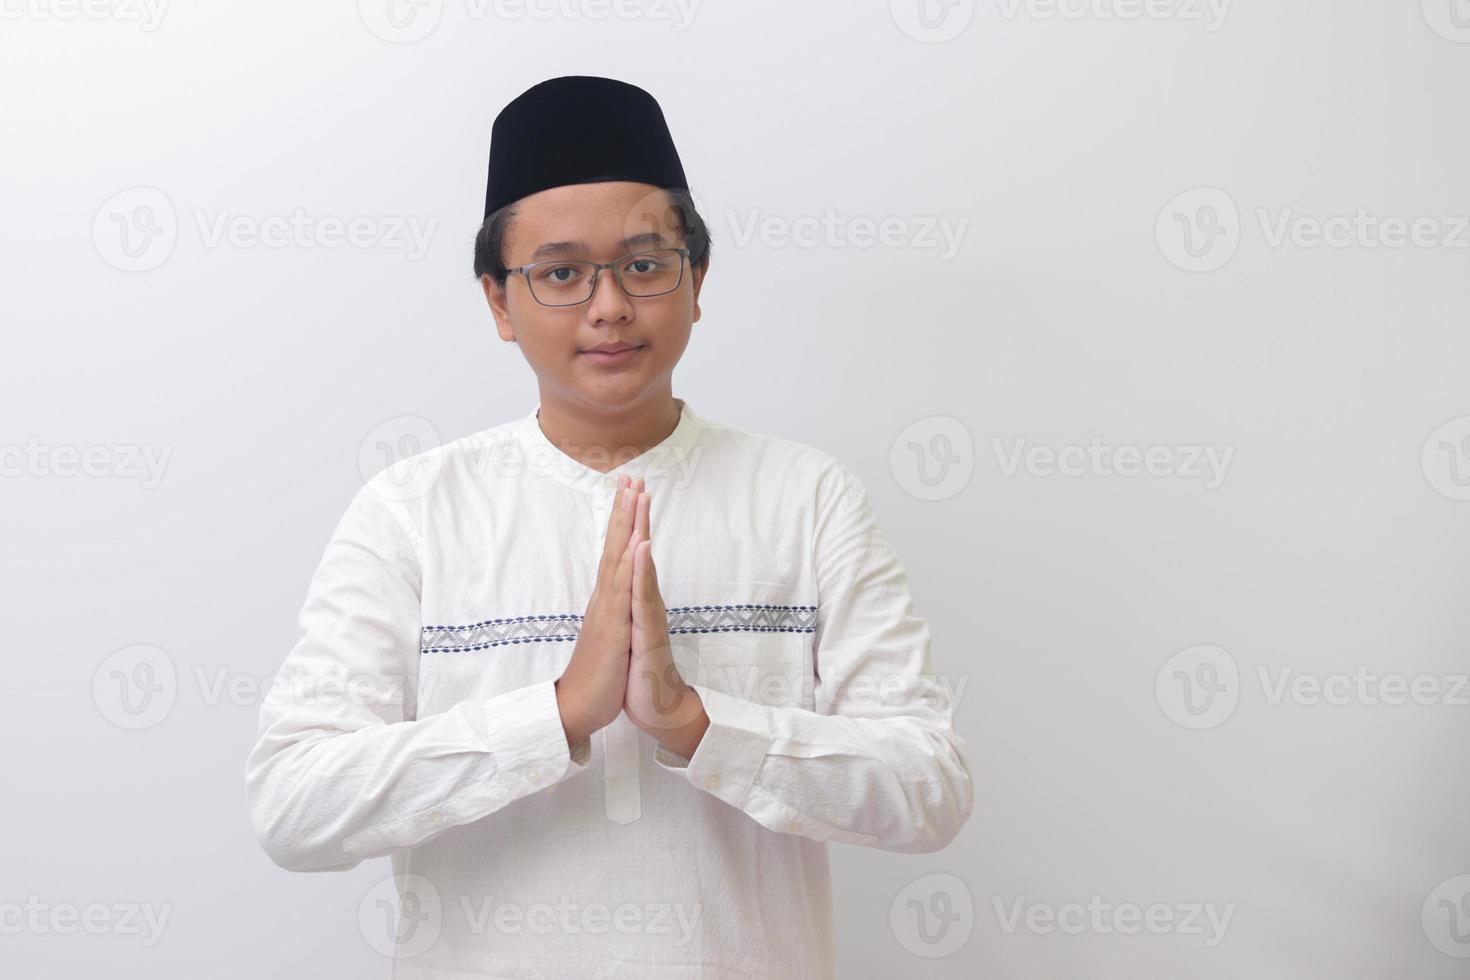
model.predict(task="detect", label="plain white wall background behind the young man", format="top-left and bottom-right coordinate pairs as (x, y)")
top-left (0, 0), bottom-right (1470, 980)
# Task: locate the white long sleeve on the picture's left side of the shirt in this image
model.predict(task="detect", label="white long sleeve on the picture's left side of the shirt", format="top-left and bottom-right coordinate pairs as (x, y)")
top-left (245, 472), bottom-right (591, 871)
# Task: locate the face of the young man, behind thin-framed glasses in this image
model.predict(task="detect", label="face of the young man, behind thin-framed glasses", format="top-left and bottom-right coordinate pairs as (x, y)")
top-left (482, 181), bottom-right (704, 410)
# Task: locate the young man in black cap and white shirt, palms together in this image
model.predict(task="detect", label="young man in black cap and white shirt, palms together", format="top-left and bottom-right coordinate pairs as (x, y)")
top-left (247, 76), bottom-right (973, 980)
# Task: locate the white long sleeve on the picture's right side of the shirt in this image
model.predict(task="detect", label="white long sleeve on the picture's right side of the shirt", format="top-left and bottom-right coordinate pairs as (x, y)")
top-left (654, 461), bottom-right (975, 852)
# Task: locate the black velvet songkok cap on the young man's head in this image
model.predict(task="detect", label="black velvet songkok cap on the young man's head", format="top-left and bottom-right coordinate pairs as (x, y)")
top-left (485, 75), bottom-right (689, 217)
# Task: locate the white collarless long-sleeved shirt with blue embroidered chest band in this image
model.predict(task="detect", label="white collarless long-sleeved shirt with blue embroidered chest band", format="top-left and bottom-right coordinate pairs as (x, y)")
top-left (245, 400), bottom-right (973, 980)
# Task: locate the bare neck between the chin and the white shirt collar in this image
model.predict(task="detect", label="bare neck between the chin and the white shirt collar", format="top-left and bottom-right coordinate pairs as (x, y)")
top-left (537, 388), bottom-right (679, 473)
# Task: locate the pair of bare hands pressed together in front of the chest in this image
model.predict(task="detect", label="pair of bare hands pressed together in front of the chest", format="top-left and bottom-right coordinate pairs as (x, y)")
top-left (556, 475), bottom-right (709, 758)
